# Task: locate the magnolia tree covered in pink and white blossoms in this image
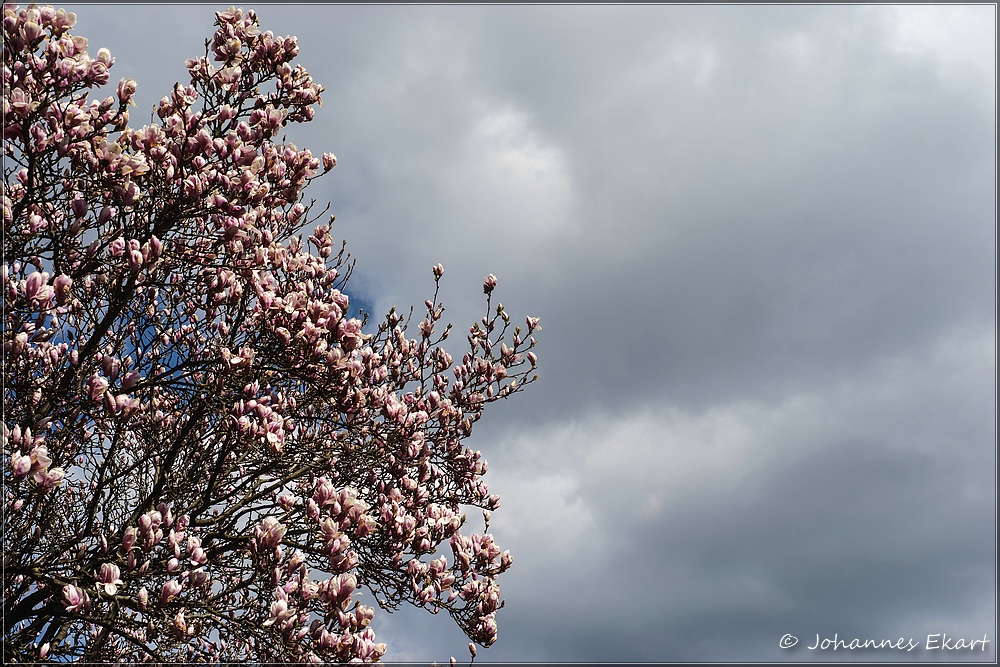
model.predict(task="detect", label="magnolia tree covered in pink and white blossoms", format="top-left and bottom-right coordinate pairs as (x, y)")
top-left (2, 5), bottom-right (537, 662)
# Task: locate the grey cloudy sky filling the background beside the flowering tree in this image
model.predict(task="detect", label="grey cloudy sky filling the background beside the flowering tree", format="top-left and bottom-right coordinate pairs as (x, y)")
top-left (67, 5), bottom-right (997, 662)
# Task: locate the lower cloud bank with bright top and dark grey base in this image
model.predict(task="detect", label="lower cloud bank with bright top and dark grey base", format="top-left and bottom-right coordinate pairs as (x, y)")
top-left (474, 337), bottom-right (995, 661)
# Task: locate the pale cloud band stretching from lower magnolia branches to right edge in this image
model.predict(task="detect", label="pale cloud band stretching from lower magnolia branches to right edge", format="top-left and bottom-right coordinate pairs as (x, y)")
top-left (489, 320), bottom-right (996, 567)
